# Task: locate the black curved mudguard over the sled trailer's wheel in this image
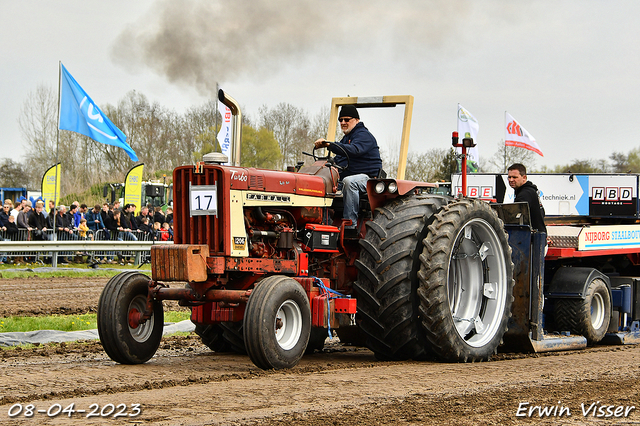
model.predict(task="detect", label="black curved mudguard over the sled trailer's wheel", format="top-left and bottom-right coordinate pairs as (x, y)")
top-left (545, 267), bottom-right (612, 300)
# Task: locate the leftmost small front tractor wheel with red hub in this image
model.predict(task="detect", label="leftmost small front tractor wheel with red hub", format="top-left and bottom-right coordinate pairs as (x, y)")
top-left (98, 272), bottom-right (164, 364)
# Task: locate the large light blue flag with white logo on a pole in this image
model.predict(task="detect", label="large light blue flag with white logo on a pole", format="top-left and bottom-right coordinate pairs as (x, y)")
top-left (58, 64), bottom-right (138, 161)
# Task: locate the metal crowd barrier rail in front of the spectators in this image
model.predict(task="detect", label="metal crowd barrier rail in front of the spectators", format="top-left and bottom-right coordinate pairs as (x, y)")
top-left (0, 229), bottom-right (173, 267)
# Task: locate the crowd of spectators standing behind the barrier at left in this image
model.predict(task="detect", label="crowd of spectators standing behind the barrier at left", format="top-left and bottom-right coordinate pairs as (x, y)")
top-left (0, 197), bottom-right (173, 264)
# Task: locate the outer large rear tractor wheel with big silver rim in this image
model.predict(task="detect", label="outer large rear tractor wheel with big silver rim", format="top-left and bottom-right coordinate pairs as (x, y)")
top-left (418, 199), bottom-right (514, 362)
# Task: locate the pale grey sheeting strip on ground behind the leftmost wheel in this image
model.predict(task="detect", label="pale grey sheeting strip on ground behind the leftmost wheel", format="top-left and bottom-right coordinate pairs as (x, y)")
top-left (0, 320), bottom-right (195, 346)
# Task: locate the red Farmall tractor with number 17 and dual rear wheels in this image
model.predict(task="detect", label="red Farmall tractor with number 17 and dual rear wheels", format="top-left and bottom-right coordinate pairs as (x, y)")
top-left (98, 91), bottom-right (514, 369)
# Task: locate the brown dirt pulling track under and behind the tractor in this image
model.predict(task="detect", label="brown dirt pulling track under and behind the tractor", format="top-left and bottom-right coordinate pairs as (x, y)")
top-left (0, 279), bottom-right (640, 426)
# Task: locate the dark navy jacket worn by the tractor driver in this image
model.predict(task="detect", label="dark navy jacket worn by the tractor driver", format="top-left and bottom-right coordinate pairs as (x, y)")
top-left (328, 122), bottom-right (382, 179)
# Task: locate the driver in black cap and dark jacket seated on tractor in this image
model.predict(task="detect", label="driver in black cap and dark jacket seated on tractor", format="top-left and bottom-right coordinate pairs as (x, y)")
top-left (315, 105), bottom-right (382, 233)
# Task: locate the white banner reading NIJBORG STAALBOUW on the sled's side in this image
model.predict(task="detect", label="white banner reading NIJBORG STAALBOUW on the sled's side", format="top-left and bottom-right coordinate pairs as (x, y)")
top-left (578, 225), bottom-right (640, 250)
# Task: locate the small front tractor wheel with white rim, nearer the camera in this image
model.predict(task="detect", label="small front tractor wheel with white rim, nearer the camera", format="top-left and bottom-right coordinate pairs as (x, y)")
top-left (244, 275), bottom-right (311, 370)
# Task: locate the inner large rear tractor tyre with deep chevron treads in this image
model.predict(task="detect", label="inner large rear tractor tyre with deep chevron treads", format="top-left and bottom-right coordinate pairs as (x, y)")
top-left (356, 194), bottom-right (451, 360)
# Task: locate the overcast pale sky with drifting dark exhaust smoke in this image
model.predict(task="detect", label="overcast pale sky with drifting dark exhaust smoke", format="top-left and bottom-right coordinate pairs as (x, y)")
top-left (0, 0), bottom-right (640, 171)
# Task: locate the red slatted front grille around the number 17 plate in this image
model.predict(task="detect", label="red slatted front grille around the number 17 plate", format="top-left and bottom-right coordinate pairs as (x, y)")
top-left (173, 166), bottom-right (226, 255)
